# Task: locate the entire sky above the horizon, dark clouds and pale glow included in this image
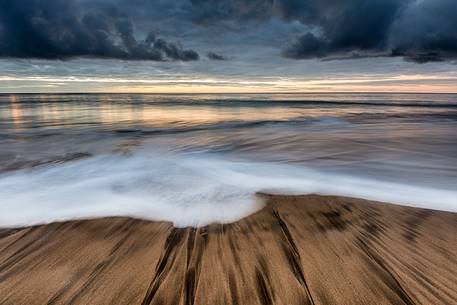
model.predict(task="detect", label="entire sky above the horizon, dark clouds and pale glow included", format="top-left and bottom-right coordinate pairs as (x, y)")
top-left (0, 0), bottom-right (457, 93)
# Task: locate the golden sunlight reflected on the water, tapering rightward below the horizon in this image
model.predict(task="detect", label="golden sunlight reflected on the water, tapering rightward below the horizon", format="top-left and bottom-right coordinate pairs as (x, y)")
top-left (3, 95), bottom-right (364, 129)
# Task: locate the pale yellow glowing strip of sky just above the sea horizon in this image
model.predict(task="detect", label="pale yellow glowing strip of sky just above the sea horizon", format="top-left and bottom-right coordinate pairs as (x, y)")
top-left (0, 72), bottom-right (457, 93)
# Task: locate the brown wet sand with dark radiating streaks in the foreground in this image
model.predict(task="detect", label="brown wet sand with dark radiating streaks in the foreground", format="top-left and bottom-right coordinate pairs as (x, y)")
top-left (0, 195), bottom-right (457, 305)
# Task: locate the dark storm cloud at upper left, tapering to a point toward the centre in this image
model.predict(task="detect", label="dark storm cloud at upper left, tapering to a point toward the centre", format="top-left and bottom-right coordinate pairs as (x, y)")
top-left (0, 0), bottom-right (199, 61)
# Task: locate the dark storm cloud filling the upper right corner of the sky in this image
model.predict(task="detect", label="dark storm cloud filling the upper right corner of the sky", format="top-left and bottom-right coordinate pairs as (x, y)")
top-left (276, 0), bottom-right (457, 63)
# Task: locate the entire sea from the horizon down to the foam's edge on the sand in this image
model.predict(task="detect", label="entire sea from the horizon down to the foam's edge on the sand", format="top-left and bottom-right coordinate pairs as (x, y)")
top-left (0, 93), bottom-right (457, 227)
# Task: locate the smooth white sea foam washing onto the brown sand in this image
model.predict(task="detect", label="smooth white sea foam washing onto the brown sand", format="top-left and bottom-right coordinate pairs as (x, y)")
top-left (0, 152), bottom-right (457, 227)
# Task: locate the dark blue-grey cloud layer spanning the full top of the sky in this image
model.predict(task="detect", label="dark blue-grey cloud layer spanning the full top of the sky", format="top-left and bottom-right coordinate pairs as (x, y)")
top-left (0, 0), bottom-right (457, 63)
